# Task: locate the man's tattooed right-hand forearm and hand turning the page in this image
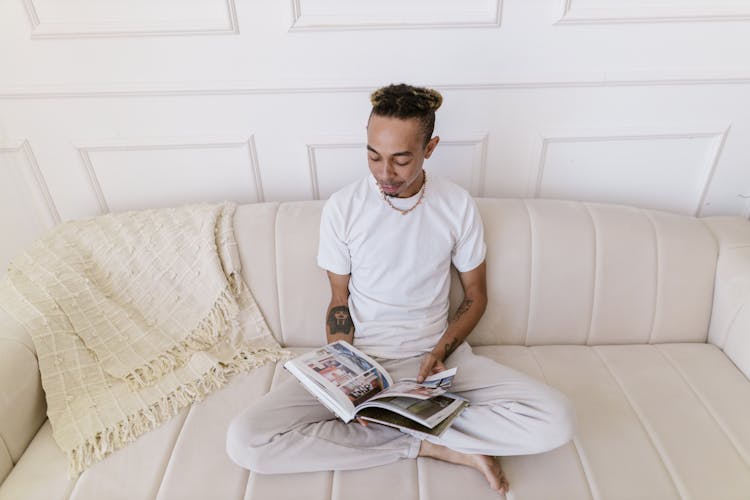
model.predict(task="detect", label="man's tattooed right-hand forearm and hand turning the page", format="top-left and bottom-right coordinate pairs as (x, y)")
top-left (417, 262), bottom-right (487, 382)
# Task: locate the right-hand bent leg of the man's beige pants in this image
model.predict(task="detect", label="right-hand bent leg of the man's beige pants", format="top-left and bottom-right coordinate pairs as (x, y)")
top-left (429, 344), bottom-right (575, 456)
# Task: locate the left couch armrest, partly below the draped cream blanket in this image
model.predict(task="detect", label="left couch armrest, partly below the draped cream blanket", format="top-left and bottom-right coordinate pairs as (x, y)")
top-left (0, 307), bottom-right (47, 483)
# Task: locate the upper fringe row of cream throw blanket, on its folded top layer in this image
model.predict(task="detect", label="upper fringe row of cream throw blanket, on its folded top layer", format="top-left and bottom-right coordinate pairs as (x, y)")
top-left (125, 282), bottom-right (240, 391)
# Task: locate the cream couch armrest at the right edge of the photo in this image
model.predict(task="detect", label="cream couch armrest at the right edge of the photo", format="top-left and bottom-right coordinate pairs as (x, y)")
top-left (702, 217), bottom-right (750, 378)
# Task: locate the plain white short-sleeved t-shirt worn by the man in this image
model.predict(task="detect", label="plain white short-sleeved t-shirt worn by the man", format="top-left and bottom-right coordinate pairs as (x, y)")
top-left (318, 173), bottom-right (486, 358)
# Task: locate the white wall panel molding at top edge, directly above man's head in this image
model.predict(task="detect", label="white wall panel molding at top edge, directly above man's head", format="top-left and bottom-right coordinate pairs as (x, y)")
top-left (289, 0), bottom-right (502, 32)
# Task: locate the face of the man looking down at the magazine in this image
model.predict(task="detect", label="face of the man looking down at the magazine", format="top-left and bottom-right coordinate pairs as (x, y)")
top-left (367, 114), bottom-right (440, 198)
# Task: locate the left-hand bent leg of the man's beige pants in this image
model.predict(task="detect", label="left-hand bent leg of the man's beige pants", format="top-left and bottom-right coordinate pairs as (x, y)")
top-left (226, 379), bottom-right (420, 474)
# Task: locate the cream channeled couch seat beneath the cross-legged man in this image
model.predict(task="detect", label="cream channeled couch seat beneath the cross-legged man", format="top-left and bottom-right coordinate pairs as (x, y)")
top-left (0, 343), bottom-right (750, 500)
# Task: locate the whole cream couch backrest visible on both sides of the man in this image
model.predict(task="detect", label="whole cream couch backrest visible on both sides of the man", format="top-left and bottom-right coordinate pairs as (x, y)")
top-left (236, 199), bottom-right (718, 346)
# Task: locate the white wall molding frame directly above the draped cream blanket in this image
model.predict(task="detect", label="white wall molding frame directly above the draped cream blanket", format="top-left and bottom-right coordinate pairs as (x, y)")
top-left (74, 135), bottom-right (265, 214)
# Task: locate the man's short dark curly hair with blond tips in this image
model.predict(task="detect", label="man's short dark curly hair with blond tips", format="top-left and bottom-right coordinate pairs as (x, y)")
top-left (370, 83), bottom-right (443, 146)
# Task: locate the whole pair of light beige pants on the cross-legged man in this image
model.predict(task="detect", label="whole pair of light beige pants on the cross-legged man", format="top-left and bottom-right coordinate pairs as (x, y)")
top-left (227, 344), bottom-right (574, 474)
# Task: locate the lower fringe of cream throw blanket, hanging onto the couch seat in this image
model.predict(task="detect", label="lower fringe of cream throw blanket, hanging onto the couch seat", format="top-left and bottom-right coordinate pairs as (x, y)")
top-left (68, 346), bottom-right (291, 478)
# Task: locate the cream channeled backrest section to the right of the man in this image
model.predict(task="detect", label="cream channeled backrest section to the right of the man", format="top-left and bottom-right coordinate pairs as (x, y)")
top-left (470, 199), bottom-right (718, 345)
